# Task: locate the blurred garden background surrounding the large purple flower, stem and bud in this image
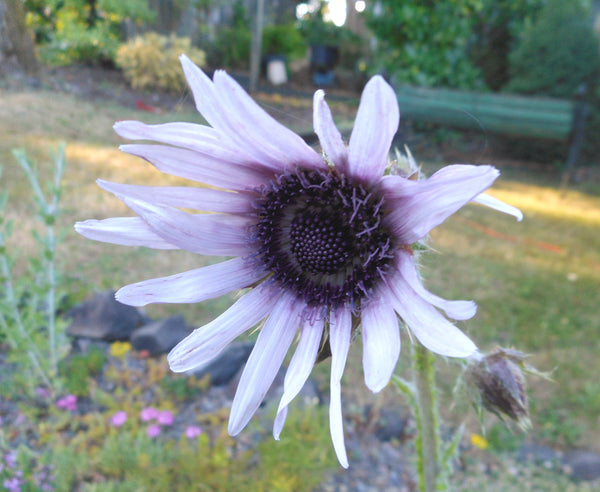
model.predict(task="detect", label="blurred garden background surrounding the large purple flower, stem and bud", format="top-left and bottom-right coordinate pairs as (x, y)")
top-left (0, 0), bottom-right (600, 491)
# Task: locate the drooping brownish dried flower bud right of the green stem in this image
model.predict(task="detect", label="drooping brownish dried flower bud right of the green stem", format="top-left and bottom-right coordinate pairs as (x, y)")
top-left (468, 348), bottom-right (530, 429)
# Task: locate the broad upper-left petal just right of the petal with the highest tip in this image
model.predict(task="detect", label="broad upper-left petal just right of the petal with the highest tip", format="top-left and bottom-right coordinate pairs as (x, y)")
top-left (214, 70), bottom-right (325, 169)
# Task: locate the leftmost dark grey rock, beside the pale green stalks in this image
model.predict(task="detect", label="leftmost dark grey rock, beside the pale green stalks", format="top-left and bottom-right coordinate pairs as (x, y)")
top-left (66, 291), bottom-right (143, 342)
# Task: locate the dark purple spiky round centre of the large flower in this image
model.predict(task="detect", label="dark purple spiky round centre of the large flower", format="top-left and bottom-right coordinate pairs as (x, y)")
top-left (255, 170), bottom-right (392, 309)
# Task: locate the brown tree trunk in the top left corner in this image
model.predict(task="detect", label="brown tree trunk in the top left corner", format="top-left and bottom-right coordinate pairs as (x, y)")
top-left (0, 0), bottom-right (40, 77)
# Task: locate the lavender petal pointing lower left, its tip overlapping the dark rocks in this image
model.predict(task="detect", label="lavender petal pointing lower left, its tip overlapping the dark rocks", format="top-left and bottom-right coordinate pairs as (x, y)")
top-left (167, 286), bottom-right (277, 372)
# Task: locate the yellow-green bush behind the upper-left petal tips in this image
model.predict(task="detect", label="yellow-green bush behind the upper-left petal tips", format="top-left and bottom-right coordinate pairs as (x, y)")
top-left (116, 32), bottom-right (206, 91)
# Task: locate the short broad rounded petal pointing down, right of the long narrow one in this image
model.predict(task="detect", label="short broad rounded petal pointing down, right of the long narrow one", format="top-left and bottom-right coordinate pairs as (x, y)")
top-left (362, 293), bottom-right (400, 393)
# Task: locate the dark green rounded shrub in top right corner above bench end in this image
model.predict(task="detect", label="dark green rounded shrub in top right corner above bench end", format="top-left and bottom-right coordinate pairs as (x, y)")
top-left (507, 0), bottom-right (600, 99)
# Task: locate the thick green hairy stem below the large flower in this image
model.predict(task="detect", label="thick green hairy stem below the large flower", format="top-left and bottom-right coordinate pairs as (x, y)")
top-left (413, 342), bottom-right (440, 492)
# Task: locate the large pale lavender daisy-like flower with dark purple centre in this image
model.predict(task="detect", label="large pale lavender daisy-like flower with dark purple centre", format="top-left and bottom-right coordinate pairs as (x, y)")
top-left (75, 56), bottom-right (520, 466)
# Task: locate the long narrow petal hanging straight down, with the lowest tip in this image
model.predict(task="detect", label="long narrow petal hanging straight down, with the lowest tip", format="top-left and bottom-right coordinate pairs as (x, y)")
top-left (329, 306), bottom-right (352, 468)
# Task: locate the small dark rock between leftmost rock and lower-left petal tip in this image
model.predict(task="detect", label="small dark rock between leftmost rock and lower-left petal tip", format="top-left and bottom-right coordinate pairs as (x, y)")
top-left (130, 314), bottom-right (191, 355)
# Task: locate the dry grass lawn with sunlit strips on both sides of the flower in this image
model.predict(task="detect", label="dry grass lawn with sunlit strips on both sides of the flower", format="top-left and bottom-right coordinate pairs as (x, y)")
top-left (0, 85), bottom-right (600, 484)
